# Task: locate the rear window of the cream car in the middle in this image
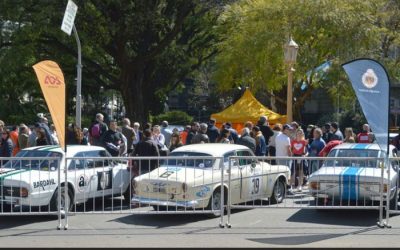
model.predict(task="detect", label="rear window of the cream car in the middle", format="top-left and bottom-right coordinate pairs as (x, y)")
top-left (161, 152), bottom-right (214, 168)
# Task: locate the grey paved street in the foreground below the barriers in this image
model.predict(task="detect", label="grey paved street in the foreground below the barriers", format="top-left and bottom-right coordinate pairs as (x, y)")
top-left (0, 197), bottom-right (400, 248)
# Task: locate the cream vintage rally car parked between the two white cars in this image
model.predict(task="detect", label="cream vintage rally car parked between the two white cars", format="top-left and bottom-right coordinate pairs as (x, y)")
top-left (132, 143), bottom-right (290, 215)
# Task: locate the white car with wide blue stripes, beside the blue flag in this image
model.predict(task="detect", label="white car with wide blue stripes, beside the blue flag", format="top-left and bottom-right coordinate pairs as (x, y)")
top-left (308, 143), bottom-right (398, 206)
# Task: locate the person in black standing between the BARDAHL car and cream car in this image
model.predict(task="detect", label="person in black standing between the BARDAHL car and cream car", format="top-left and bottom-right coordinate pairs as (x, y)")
top-left (134, 129), bottom-right (160, 175)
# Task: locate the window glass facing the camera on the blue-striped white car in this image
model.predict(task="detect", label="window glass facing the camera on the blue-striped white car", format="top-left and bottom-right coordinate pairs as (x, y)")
top-left (324, 148), bottom-right (385, 168)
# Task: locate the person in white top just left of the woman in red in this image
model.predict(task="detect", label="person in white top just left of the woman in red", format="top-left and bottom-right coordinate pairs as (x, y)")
top-left (275, 124), bottom-right (293, 167)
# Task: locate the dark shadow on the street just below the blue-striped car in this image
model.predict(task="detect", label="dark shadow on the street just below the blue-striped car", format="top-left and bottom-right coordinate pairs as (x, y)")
top-left (287, 209), bottom-right (379, 227)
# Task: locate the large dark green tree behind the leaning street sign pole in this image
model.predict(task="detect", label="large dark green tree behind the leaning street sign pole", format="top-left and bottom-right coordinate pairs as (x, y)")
top-left (0, 0), bottom-right (224, 122)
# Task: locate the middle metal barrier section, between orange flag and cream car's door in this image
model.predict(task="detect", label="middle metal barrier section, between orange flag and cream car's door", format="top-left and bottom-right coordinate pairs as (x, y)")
top-left (64, 156), bottom-right (227, 229)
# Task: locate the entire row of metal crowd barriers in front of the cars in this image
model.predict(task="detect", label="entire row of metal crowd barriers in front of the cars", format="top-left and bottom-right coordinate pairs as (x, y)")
top-left (0, 156), bottom-right (400, 229)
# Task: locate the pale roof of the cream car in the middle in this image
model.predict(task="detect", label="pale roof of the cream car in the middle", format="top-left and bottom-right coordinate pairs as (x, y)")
top-left (172, 143), bottom-right (251, 156)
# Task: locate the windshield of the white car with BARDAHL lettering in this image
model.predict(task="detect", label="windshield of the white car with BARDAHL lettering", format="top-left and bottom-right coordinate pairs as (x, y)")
top-left (3, 150), bottom-right (62, 171)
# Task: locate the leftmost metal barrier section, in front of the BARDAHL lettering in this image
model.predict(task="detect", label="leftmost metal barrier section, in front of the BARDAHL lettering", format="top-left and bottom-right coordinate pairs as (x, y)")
top-left (0, 157), bottom-right (61, 228)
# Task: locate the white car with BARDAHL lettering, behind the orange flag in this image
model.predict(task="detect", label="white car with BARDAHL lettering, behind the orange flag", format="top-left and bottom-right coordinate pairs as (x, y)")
top-left (0, 145), bottom-right (130, 211)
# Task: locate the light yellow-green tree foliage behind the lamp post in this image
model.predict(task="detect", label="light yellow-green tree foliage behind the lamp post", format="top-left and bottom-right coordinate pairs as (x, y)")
top-left (214, 0), bottom-right (385, 119)
